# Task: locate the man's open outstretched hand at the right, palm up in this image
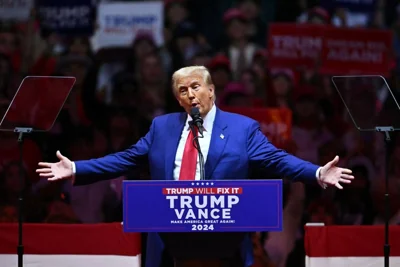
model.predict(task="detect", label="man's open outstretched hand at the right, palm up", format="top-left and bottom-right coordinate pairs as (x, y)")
top-left (319, 156), bottom-right (354, 189)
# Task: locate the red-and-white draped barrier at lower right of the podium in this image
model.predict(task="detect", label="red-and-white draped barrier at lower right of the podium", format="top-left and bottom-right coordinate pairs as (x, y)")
top-left (304, 225), bottom-right (400, 267)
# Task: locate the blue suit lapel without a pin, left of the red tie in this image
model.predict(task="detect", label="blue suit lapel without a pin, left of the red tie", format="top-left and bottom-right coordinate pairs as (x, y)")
top-left (164, 112), bottom-right (187, 180)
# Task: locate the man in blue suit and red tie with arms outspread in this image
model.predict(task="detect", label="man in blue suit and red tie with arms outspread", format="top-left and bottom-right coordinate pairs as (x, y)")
top-left (37, 66), bottom-right (354, 267)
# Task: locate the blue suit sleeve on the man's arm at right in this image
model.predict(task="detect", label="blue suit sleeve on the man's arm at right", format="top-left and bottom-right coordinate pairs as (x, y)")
top-left (247, 122), bottom-right (319, 182)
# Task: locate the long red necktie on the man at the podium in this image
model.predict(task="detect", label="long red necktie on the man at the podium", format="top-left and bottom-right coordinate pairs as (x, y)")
top-left (179, 127), bottom-right (197, 180)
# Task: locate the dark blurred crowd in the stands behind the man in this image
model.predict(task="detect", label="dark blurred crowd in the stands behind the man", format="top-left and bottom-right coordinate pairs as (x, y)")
top-left (0, 0), bottom-right (400, 266)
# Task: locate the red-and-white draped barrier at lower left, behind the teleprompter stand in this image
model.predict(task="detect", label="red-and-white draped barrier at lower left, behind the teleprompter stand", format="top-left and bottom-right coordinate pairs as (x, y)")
top-left (0, 223), bottom-right (141, 267)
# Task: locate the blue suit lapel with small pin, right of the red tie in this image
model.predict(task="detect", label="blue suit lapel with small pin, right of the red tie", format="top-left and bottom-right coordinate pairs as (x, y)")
top-left (205, 108), bottom-right (229, 180)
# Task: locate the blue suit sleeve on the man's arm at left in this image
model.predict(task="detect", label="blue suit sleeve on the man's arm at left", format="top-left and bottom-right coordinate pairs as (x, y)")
top-left (74, 118), bottom-right (155, 185)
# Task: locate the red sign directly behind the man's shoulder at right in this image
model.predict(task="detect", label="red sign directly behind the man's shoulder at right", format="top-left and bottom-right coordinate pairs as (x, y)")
top-left (221, 107), bottom-right (292, 148)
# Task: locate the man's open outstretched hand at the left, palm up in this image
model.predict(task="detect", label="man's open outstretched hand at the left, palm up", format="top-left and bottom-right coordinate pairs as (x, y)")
top-left (36, 151), bottom-right (73, 181)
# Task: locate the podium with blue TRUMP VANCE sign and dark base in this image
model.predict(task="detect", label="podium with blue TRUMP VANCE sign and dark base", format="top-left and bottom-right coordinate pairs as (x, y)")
top-left (123, 180), bottom-right (283, 266)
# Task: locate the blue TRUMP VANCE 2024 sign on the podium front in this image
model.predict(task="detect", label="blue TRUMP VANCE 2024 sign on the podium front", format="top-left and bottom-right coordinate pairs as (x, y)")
top-left (123, 180), bottom-right (283, 232)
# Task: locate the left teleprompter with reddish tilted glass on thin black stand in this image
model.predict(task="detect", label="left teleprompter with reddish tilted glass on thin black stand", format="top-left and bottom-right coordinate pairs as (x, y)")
top-left (0, 76), bottom-right (75, 267)
